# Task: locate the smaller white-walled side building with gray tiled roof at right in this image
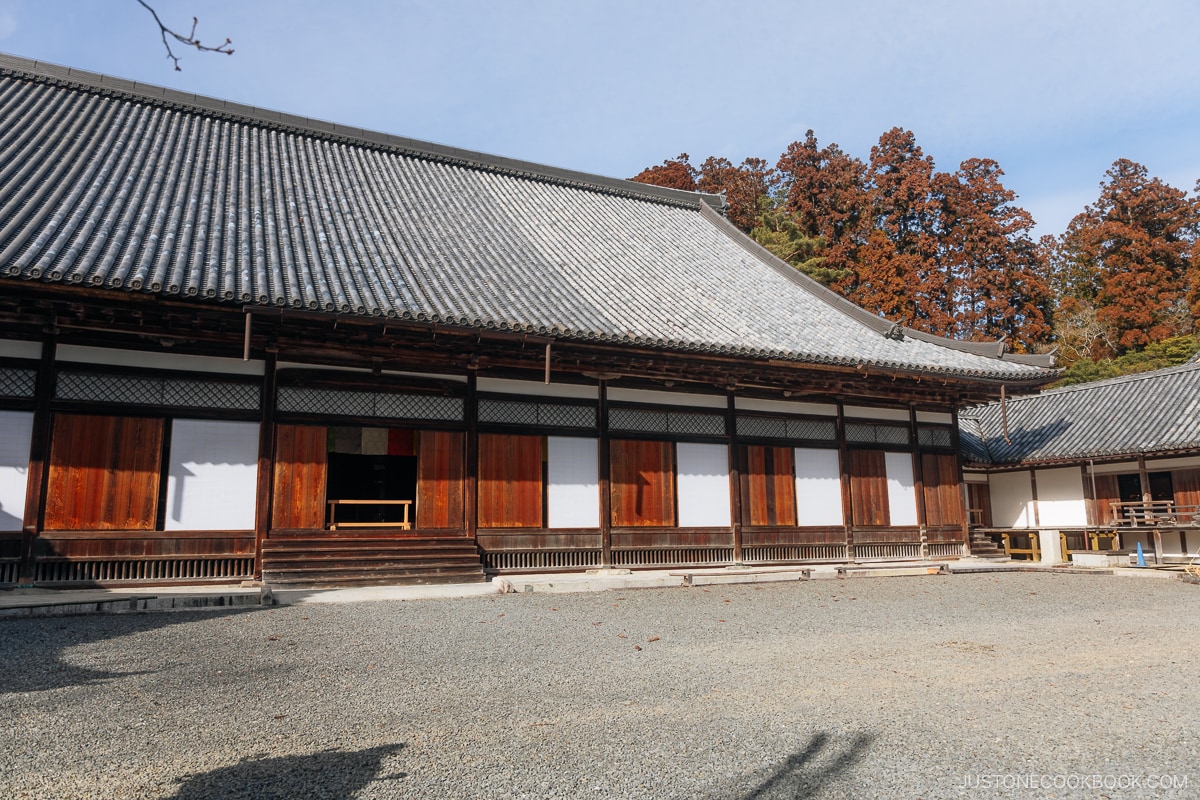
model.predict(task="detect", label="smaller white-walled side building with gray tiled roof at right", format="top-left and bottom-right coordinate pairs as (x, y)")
top-left (959, 357), bottom-right (1200, 563)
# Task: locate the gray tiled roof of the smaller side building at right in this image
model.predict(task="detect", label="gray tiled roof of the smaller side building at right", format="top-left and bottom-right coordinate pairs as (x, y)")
top-left (959, 362), bottom-right (1200, 464)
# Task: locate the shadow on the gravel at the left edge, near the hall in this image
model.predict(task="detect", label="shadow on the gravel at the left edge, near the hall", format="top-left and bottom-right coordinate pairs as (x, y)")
top-left (0, 608), bottom-right (259, 696)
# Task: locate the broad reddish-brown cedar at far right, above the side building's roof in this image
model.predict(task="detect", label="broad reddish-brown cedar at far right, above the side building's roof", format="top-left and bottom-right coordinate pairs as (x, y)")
top-left (1056, 158), bottom-right (1198, 351)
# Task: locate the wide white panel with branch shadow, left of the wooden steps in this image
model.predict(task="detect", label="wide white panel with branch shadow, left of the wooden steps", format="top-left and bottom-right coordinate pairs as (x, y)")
top-left (166, 420), bottom-right (258, 530)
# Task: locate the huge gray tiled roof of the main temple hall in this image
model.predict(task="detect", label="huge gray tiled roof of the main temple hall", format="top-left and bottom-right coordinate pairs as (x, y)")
top-left (0, 56), bottom-right (1049, 383)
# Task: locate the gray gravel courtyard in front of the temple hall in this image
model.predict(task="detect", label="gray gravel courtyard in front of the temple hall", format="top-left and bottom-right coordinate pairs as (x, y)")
top-left (0, 573), bottom-right (1200, 800)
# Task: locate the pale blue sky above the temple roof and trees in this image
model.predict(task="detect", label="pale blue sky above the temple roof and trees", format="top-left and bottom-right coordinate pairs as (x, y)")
top-left (0, 0), bottom-right (1200, 234)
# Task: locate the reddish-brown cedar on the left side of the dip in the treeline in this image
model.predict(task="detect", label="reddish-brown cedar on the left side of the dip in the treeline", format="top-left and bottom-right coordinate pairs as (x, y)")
top-left (935, 158), bottom-right (1051, 351)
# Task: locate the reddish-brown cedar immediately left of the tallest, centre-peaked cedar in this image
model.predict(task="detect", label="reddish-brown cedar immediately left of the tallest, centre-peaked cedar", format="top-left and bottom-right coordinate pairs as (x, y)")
top-left (778, 131), bottom-right (878, 287)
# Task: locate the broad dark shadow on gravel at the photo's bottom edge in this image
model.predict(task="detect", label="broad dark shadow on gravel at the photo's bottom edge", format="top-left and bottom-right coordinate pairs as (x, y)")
top-left (174, 744), bottom-right (408, 800)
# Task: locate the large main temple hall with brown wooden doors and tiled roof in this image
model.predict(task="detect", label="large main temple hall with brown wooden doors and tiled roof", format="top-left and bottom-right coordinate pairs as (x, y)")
top-left (0, 56), bottom-right (1055, 587)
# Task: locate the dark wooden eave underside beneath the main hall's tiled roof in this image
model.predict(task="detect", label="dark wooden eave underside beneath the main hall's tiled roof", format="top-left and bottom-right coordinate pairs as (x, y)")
top-left (0, 285), bottom-right (1040, 407)
